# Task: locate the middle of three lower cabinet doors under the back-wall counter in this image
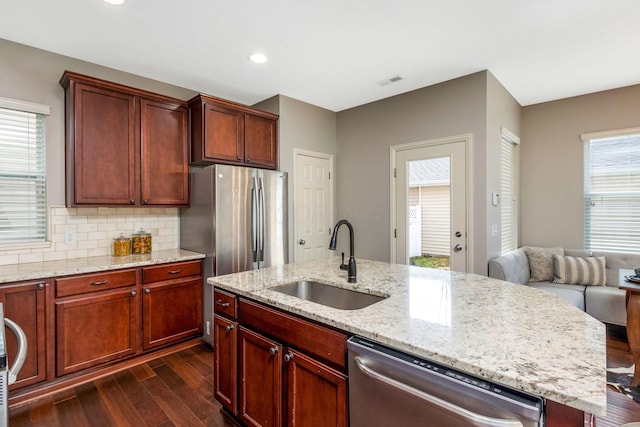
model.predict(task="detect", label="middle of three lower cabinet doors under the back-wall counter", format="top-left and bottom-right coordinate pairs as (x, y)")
top-left (56, 288), bottom-right (140, 375)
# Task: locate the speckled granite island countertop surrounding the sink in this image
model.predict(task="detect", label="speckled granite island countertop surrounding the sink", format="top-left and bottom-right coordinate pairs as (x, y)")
top-left (207, 258), bottom-right (606, 415)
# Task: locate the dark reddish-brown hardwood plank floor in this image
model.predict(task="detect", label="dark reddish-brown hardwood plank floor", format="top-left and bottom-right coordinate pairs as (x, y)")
top-left (9, 326), bottom-right (640, 427)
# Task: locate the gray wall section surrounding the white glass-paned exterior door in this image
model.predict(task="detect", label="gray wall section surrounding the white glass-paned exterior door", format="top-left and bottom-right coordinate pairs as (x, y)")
top-left (336, 72), bottom-right (487, 274)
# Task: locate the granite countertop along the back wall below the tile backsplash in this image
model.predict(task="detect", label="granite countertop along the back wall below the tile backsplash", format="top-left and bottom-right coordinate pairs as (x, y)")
top-left (0, 249), bottom-right (205, 283)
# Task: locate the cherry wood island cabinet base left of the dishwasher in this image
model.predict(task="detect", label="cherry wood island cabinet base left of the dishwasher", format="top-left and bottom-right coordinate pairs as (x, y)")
top-left (214, 290), bottom-right (349, 427)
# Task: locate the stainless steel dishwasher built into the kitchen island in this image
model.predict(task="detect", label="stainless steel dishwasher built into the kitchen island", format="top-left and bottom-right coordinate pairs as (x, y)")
top-left (347, 337), bottom-right (544, 427)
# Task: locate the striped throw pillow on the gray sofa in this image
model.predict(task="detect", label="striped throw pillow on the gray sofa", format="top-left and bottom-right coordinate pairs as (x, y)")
top-left (553, 255), bottom-right (607, 286)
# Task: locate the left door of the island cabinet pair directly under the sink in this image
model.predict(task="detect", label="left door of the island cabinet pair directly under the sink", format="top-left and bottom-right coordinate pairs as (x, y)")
top-left (238, 327), bottom-right (282, 427)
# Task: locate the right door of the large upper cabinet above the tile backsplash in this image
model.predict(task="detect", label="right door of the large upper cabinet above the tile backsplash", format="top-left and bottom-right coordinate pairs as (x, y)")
top-left (140, 98), bottom-right (189, 205)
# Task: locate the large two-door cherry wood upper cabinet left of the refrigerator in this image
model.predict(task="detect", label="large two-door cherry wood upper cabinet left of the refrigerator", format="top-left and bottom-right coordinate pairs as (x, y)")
top-left (60, 71), bottom-right (190, 207)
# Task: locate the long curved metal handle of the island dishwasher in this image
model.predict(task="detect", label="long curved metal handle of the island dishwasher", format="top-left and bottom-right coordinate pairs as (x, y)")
top-left (354, 356), bottom-right (523, 427)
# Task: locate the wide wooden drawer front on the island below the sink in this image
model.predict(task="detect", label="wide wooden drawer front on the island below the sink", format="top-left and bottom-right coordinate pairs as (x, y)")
top-left (238, 298), bottom-right (347, 369)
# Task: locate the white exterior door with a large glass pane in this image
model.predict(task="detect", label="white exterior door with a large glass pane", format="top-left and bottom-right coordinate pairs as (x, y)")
top-left (392, 138), bottom-right (467, 272)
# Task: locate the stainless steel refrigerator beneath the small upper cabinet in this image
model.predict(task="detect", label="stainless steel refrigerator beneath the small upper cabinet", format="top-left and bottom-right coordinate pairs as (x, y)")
top-left (180, 165), bottom-right (289, 345)
